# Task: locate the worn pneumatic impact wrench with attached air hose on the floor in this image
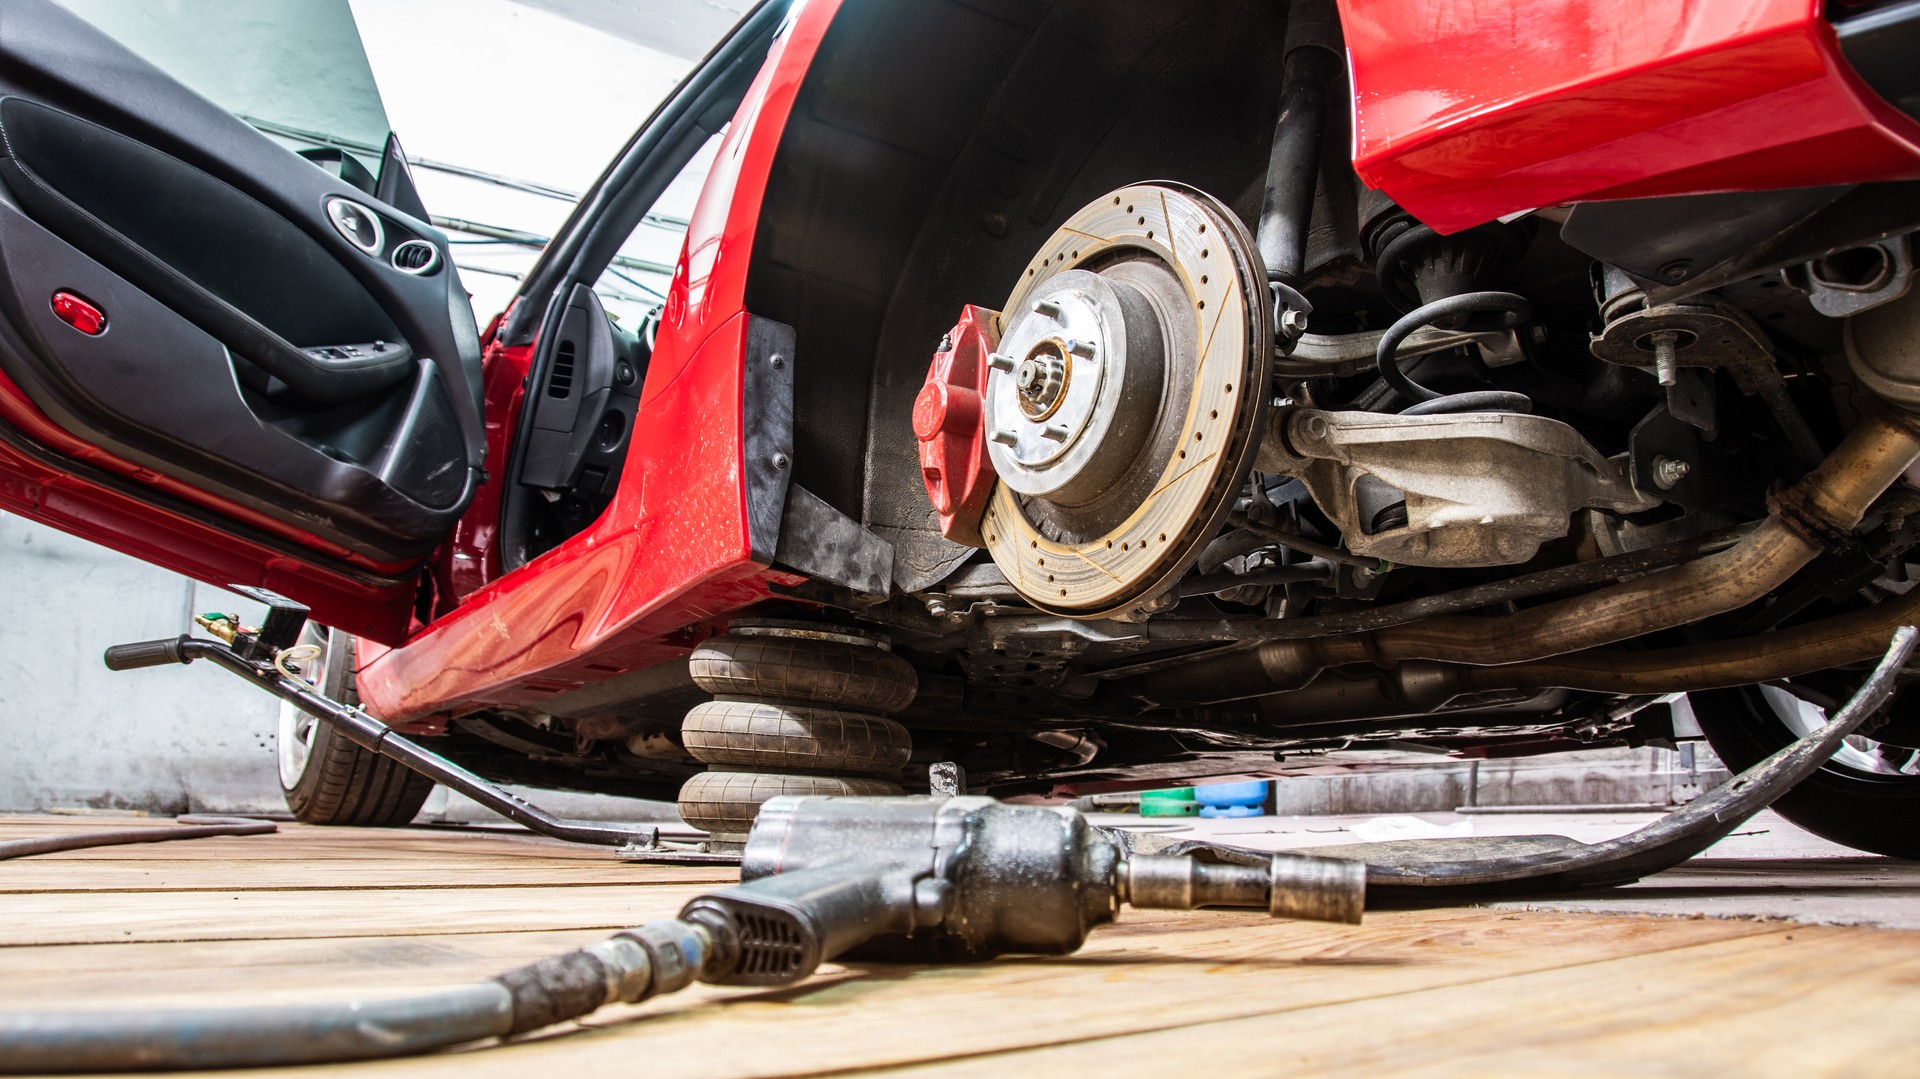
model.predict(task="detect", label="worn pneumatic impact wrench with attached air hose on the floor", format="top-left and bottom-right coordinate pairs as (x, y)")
top-left (0, 797), bottom-right (1367, 1071)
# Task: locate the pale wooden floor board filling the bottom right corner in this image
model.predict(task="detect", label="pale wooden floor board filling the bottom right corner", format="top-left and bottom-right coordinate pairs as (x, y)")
top-left (908, 925), bottom-right (1920, 1079)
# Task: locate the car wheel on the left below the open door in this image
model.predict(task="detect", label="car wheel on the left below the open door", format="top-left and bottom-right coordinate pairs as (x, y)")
top-left (276, 622), bottom-right (434, 827)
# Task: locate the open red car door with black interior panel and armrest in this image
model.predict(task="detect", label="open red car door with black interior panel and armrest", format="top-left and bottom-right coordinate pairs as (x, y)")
top-left (0, 0), bottom-right (484, 643)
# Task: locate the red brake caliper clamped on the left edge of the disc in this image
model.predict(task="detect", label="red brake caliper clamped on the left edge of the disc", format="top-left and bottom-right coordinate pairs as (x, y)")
top-left (914, 305), bottom-right (1000, 547)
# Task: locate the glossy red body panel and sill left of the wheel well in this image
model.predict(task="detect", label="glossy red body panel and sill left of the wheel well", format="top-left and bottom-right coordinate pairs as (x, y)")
top-left (357, 0), bottom-right (839, 722)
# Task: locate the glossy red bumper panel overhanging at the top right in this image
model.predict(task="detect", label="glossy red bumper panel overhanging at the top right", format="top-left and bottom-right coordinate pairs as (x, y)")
top-left (1338, 0), bottom-right (1920, 232)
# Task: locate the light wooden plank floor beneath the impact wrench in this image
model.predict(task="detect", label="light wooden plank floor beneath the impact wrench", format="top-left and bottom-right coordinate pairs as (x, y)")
top-left (0, 818), bottom-right (1920, 1079)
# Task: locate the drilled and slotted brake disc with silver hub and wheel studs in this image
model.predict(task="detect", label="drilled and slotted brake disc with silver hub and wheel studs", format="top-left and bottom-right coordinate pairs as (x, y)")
top-left (981, 184), bottom-right (1273, 618)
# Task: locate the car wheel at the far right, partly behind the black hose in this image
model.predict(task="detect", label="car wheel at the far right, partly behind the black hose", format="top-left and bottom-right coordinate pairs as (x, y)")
top-left (1690, 685), bottom-right (1920, 858)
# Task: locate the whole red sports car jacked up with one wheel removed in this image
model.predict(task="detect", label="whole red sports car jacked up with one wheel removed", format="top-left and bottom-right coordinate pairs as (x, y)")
top-left (0, 0), bottom-right (1920, 856)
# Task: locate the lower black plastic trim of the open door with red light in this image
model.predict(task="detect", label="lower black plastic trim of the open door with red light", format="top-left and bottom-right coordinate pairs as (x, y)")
top-left (0, 200), bottom-right (474, 563)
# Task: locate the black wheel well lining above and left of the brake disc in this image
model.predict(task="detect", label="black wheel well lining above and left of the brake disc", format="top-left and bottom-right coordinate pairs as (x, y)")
top-left (747, 0), bottom-right (1297, 580)
